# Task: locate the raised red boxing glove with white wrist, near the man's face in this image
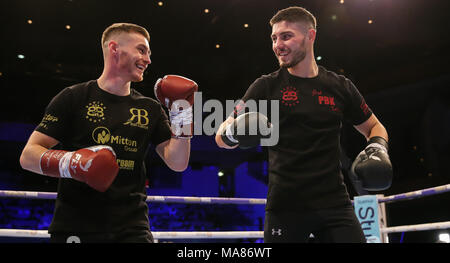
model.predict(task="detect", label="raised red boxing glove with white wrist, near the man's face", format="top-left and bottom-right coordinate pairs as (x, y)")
top-left (155, 75), bottom-right (198, 138)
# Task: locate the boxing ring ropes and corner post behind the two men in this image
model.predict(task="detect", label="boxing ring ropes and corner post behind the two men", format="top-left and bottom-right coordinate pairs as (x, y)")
top-left (0, 184), bottom-right (450, 243)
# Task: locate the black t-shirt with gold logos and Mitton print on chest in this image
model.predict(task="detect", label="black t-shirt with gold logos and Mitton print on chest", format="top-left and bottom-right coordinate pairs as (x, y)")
top-left (36, 80), bottom-right (171, 232)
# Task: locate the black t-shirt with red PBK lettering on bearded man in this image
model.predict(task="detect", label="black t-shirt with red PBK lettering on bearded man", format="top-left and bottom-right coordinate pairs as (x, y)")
top-left (235, 66), bottom-right (372, 210)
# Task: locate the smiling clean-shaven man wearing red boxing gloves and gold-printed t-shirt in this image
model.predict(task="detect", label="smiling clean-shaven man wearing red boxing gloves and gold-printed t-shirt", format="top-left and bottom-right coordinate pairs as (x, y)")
top-left (20, 23), bottom-right (198, 242)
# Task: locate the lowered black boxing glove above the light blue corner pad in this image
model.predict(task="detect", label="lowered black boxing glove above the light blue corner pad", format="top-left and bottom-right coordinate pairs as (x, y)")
top-left (350, 136), bottom-right (393, 191)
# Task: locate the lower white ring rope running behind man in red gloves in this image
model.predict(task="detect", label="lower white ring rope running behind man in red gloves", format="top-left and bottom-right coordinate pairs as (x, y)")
top-left (0, 229), bottom-right (264, 239)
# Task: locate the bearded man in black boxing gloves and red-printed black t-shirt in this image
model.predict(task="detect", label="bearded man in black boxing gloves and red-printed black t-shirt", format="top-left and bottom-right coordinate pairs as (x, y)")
top-left (216, 7), bottom-right (392, 243)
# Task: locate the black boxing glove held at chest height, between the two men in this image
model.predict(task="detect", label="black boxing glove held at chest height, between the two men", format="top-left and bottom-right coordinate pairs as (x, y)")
top-left (221, 112), bottom-right (272, 149)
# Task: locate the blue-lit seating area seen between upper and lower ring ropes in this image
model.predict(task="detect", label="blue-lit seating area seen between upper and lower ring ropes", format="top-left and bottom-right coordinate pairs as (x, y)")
top-left (0, 198), bottom-right (264, 242)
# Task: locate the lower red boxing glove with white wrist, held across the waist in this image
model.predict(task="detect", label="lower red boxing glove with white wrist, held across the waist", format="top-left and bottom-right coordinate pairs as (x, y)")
top-left (40, 145), bottom-right (119, 192)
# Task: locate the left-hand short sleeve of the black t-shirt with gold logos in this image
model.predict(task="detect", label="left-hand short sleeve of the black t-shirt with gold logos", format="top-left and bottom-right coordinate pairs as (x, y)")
top-left (35, 88), bottom-right (71, 142)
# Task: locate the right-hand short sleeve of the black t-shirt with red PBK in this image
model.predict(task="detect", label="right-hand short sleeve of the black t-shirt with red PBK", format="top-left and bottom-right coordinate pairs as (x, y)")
top-left (344, 79), bottom-right (372, 125)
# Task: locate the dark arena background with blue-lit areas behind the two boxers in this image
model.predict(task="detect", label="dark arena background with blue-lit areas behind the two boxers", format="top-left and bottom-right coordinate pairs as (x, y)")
top-left (0, 0), bottom-right (450, 242)
